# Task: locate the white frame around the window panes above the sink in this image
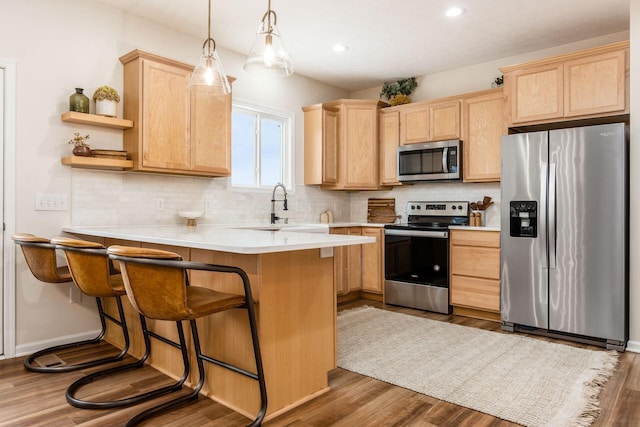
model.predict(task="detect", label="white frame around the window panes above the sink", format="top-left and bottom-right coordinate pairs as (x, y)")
top-left (227, 99), bottom-right (295, 193)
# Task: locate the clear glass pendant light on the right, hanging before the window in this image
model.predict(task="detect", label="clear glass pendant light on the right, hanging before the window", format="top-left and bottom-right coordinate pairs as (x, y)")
top-left (243, 0), bottom-right (293, 77)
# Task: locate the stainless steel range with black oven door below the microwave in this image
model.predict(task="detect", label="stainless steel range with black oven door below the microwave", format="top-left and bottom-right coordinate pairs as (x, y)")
top-left (384, 202), bottom-right (469, 314)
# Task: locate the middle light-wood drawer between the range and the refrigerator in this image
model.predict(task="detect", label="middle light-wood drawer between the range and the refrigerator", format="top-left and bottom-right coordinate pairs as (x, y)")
top-left (451, 246), bottom-right (500, 280)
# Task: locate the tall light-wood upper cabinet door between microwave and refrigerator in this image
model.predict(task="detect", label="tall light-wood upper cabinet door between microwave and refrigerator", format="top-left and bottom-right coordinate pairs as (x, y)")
top-left (462, 89), bottom-right (507, 182)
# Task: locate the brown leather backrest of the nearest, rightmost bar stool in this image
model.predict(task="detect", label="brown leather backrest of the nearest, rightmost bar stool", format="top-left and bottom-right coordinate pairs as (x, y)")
top-left (108, 245), bottom-right (185, 320)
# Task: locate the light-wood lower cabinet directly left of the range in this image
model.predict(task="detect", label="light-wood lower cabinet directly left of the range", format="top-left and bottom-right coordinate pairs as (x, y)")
top-left (331, 227), bottom-right (384, 302)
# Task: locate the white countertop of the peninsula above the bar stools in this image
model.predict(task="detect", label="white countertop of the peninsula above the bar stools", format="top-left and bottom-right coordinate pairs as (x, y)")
top-left (62, 224), bottom-right (375, 254)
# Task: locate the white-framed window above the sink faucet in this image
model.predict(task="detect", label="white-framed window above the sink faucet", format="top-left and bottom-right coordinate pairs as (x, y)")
top-left (231, 104), bottom-right (293, 190)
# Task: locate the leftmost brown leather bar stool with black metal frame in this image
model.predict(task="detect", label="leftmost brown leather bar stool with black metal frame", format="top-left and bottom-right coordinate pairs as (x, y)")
top-left (12, 233), bottom-right (129, 373)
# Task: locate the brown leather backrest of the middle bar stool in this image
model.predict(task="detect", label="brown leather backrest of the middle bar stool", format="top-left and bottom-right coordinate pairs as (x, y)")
top-left (51, 237), bottom-right (122, 297)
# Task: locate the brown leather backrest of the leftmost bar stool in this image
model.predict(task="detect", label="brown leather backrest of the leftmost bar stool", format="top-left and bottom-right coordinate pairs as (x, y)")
top-left (12, 233), bottom-right (71, 283)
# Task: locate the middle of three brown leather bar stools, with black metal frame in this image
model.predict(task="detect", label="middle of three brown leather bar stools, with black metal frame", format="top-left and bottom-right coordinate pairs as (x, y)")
top-left (51, 237), bottom-right (189, 409)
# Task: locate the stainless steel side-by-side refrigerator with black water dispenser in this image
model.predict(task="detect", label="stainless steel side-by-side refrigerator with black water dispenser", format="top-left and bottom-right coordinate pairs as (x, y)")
top-left (500, 123), bottom-right (629, 351)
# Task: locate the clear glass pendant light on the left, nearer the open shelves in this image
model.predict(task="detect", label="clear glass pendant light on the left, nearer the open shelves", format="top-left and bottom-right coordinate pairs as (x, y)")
top-left (189, 0), bottom-right (231, 95)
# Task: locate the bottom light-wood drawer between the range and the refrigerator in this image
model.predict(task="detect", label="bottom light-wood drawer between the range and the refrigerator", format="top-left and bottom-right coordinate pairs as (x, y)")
top-left (451, 275), bottom-right (500, 312)
